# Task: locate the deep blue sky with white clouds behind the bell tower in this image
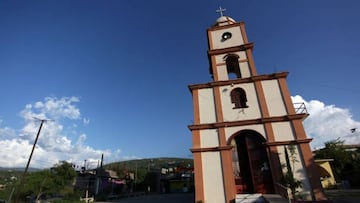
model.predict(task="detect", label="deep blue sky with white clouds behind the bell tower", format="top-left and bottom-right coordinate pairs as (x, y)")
top-left (0, 0), bottom-right (360, 167)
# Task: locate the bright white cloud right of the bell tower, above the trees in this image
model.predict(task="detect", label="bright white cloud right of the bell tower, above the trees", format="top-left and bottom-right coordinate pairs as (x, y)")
top-left (292, 95), bottom-right (360, 149)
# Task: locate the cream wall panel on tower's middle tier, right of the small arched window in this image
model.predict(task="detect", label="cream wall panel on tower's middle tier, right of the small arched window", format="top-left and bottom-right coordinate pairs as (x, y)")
top-left (261, 80), bottom-right (287, 116)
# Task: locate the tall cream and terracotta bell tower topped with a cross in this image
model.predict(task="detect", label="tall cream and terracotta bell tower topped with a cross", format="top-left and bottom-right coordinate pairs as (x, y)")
top-left (189, 7), bottom-right (324, 203)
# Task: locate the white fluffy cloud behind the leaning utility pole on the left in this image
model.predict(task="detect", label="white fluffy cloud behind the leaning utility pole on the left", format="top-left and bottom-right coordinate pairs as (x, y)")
top-left (0, 97), bottom-right (121, 168)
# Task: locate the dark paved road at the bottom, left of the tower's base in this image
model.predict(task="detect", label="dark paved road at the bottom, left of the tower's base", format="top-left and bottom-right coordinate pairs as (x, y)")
top-left (97, 193), bottom-right (194, 203)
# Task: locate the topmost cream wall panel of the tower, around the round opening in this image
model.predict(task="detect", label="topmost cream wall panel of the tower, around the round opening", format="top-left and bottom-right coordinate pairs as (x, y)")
top-left (210, 27), bottom-right (244, 49)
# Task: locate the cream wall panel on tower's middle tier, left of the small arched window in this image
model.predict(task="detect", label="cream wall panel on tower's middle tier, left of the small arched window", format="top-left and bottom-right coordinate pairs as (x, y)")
top-left (198, 88), bottom-right (216, 123)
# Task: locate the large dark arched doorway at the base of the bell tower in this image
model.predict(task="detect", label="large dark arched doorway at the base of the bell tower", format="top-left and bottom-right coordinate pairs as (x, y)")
top-left (230, 130), bottom-right (274, 194)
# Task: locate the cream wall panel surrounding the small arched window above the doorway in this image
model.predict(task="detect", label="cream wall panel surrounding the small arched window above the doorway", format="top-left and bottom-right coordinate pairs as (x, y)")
top-left (220, 83), bottom-right (261, 121)
